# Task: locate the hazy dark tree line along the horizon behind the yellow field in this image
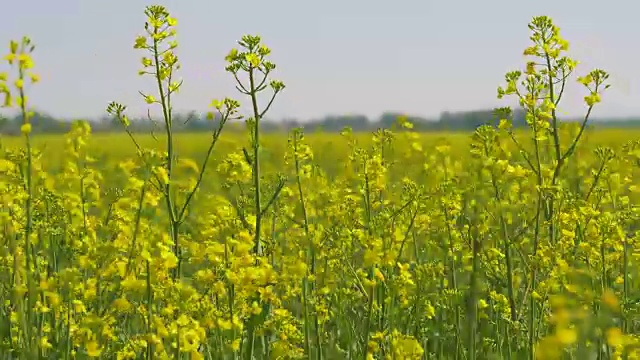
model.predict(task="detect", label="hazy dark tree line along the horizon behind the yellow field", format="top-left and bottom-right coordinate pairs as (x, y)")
top-left (0, 110), bottom-right (640, 135)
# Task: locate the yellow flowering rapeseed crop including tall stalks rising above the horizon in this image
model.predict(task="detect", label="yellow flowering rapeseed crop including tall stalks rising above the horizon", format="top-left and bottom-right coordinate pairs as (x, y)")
top-left (0, 6), bottom-right (640, 360)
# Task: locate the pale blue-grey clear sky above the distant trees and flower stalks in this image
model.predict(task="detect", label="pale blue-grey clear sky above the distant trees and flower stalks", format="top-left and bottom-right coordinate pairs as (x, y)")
top-left (0, 0), bottom-right (640, 119)
